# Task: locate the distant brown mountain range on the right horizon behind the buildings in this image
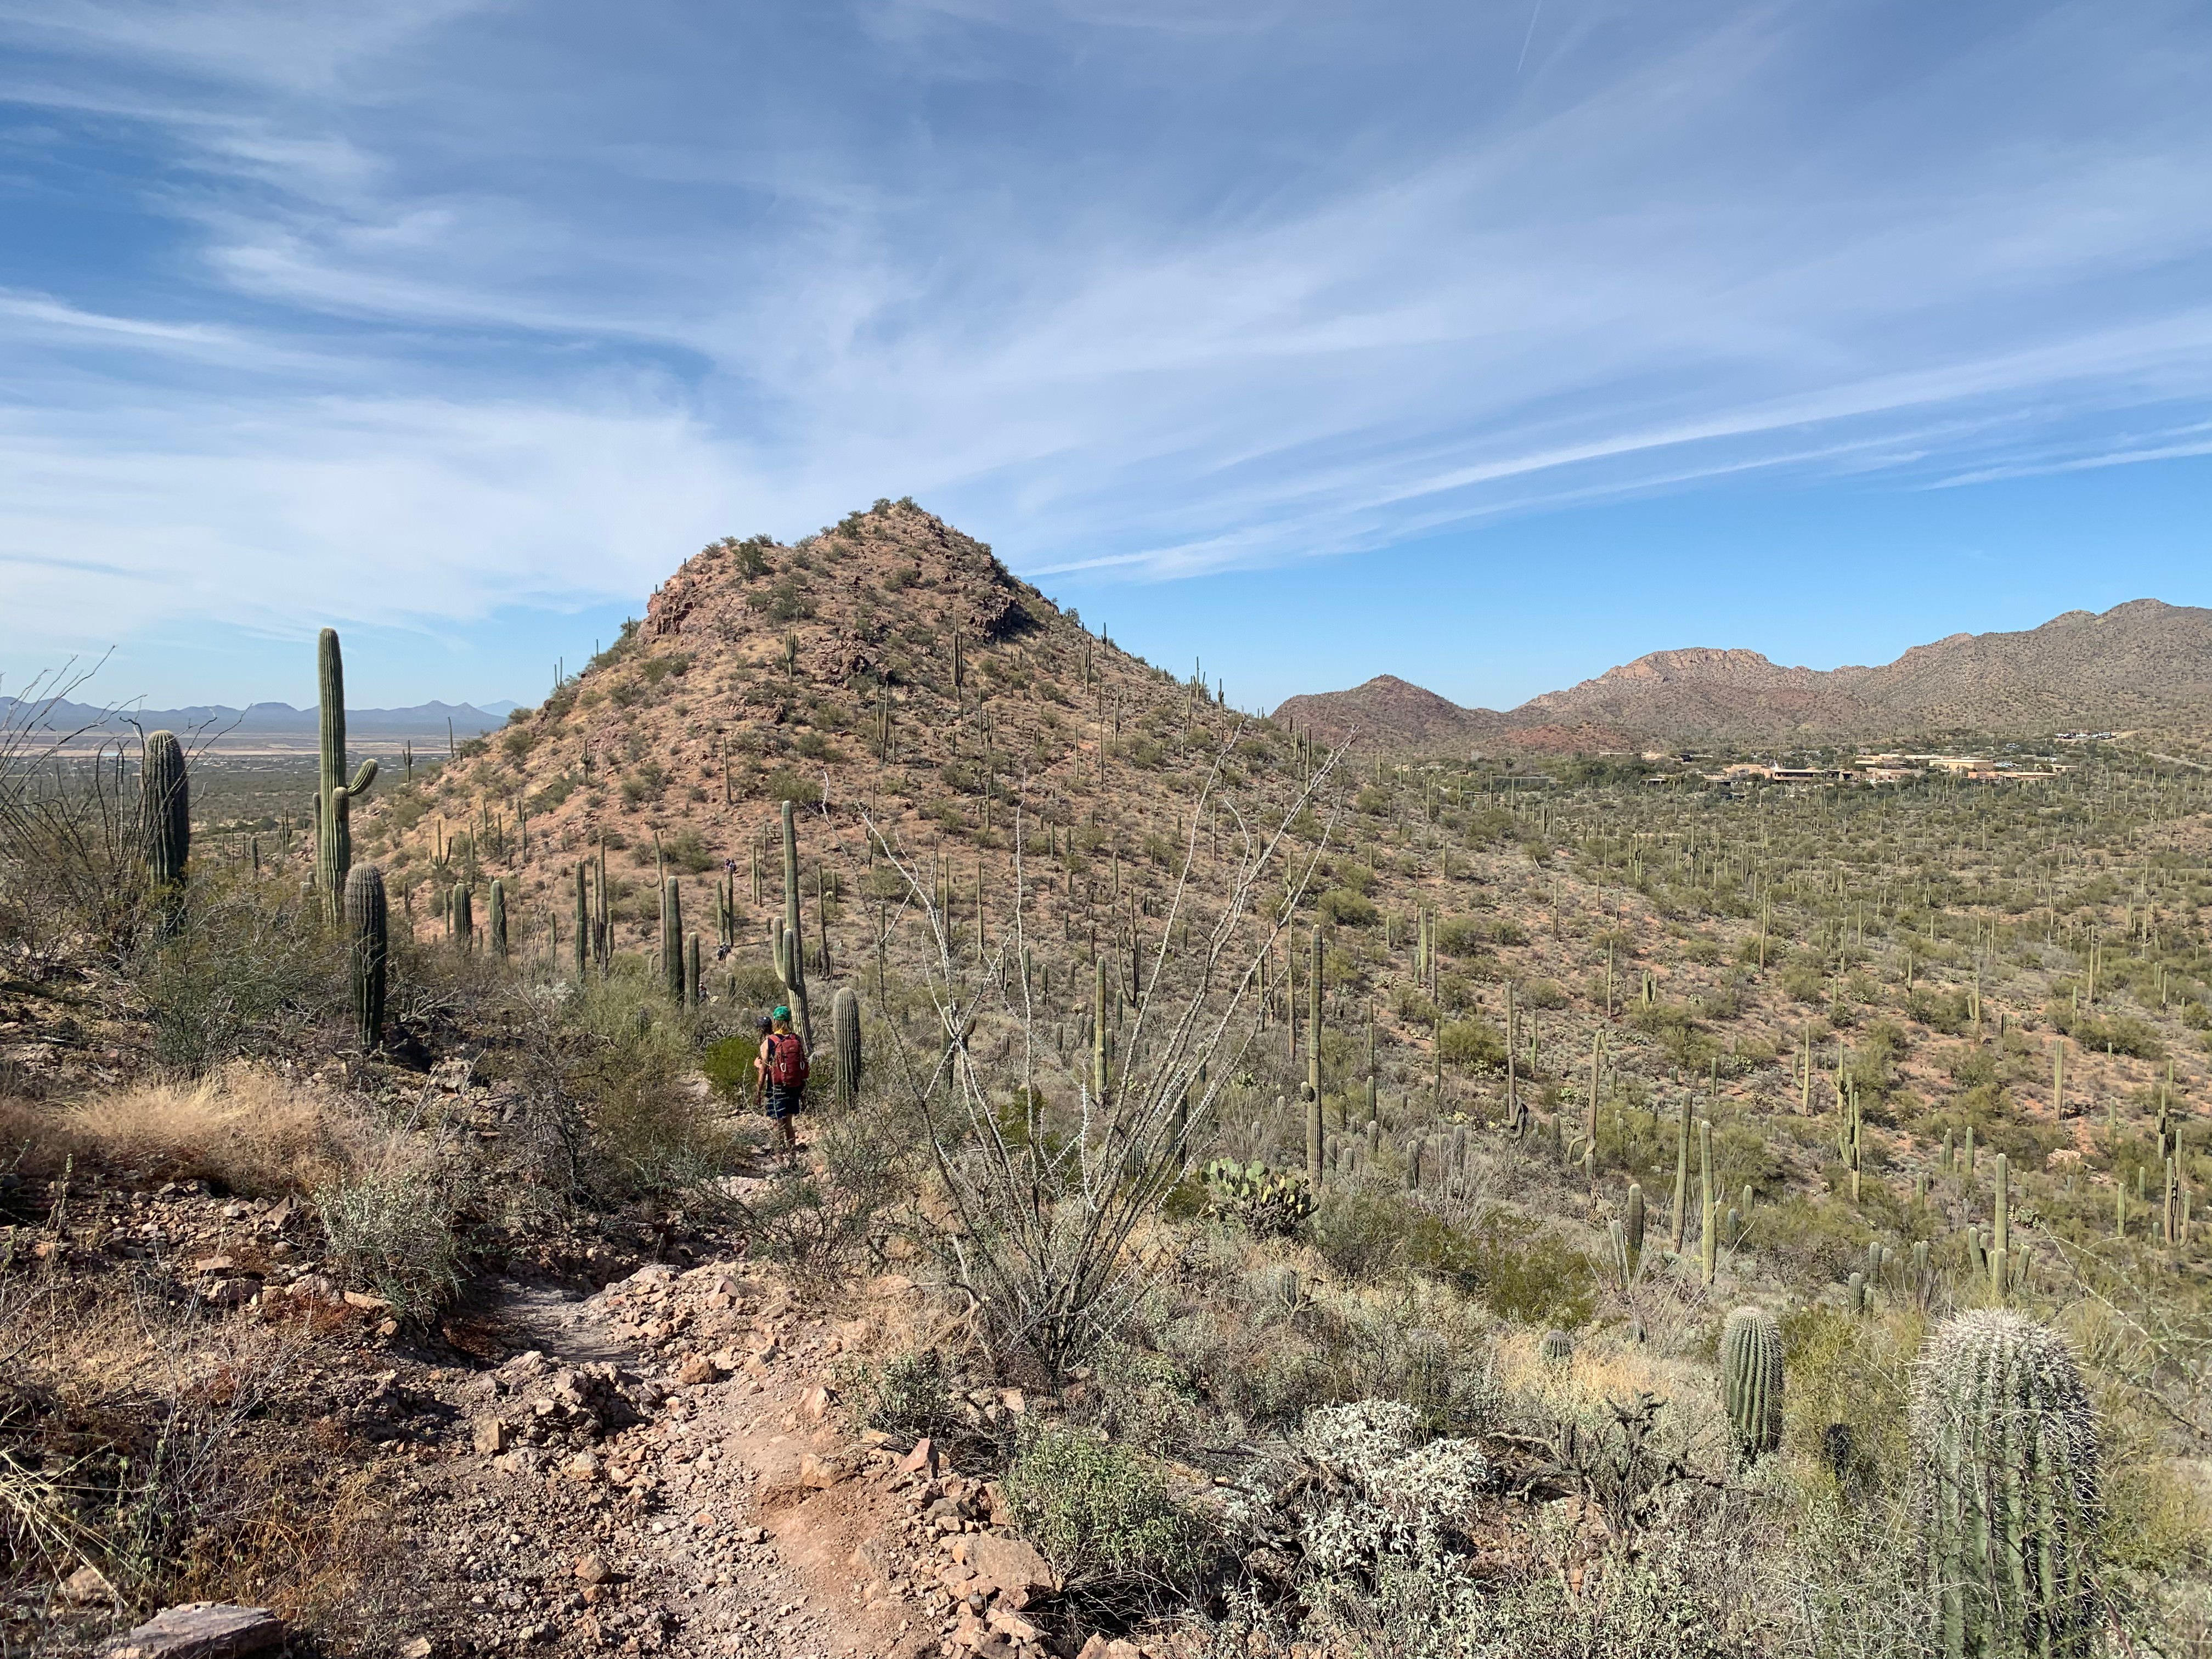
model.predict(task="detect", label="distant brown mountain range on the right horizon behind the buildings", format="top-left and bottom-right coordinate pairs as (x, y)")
top-left (1274, 600), bottom-right (2212, 752)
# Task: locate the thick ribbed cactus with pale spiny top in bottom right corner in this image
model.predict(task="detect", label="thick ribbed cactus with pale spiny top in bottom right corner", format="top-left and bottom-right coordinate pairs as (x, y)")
top-left (1911, 1307), bottom-right (2101, 1659)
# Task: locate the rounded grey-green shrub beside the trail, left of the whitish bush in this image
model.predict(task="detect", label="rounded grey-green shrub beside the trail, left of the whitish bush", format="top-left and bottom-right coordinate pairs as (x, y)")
top-left (1007, 1429), bottom-right (1197, 1599)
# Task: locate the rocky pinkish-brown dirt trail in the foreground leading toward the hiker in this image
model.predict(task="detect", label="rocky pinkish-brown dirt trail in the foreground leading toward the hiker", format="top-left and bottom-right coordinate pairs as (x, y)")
top-left (378, 1261), bottom-right (986, 1659)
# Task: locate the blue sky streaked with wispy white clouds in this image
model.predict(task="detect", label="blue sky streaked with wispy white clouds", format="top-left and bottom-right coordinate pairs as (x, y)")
top-left (0, 0), bottom-right (2212, 706)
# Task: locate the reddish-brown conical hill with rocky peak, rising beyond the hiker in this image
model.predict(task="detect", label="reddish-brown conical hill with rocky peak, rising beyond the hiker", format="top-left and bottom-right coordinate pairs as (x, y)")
top-left (356, 502), bottom-right (1299, 962)
